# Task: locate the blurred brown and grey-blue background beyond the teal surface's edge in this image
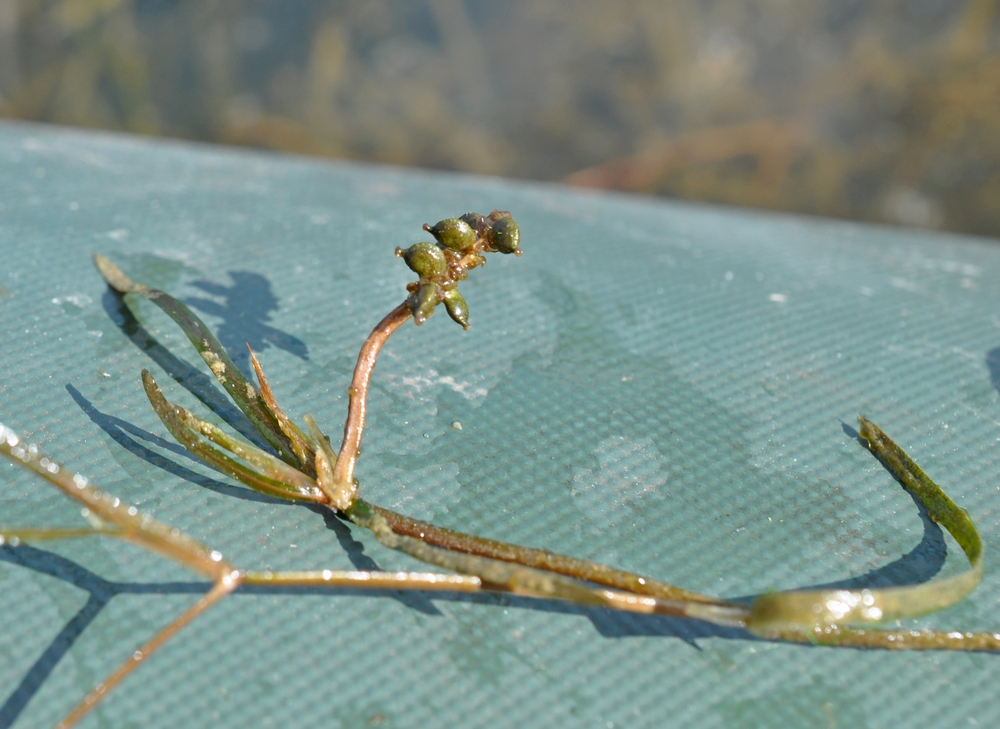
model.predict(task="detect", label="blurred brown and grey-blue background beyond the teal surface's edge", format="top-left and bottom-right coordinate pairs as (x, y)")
top-left (0, 0), bottom-right (1000, 237)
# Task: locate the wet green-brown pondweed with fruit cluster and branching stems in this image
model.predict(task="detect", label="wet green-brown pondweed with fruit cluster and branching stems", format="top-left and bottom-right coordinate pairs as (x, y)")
top-left (0, 211), bottom-right (1000, 727)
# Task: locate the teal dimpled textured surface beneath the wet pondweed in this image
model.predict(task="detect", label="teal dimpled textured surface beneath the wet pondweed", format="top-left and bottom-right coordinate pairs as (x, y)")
top-left (0, 125), bottom-right (1000, 727)
